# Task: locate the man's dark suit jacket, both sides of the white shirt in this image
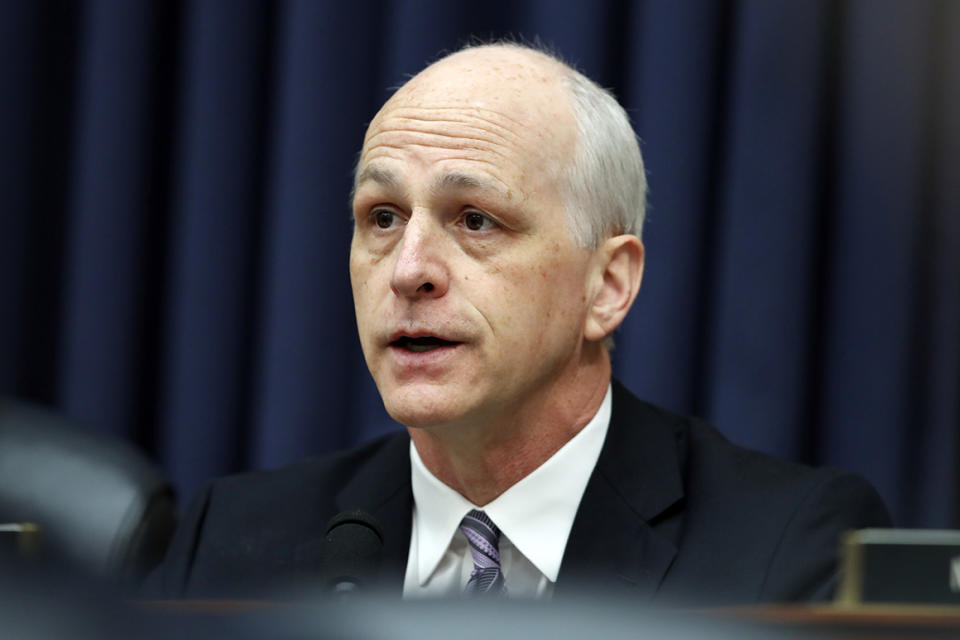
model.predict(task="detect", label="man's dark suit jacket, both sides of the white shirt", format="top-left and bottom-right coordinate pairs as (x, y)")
top-left (152, 382), bottom-right (890, 605)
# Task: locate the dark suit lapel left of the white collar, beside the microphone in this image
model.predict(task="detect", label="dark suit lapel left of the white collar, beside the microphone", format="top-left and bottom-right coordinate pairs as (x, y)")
top-left (336, 432), bottom-right (413, 592)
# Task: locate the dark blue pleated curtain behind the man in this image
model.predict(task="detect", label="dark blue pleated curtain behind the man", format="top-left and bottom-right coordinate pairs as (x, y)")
top-left (0, 0), bottom-right (960, 527)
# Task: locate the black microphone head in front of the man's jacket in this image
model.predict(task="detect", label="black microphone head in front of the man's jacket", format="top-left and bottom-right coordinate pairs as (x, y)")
top-left (322, 509), bottom-right (383, 598)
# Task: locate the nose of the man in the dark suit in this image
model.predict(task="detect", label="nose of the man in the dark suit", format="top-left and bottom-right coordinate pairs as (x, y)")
top-left (390, 213), bottom-right (450, 299)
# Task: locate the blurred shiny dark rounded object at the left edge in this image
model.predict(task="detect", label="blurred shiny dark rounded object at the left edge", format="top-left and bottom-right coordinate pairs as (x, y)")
top-left (0, 400), bottom-right (176, 585)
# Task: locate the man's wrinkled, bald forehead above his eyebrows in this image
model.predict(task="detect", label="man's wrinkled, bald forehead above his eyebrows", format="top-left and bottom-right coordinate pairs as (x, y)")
top-left (357, 50), bottom-right (575, 195)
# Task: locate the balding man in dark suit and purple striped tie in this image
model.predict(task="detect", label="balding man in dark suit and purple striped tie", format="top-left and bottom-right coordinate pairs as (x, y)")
top-left (152, 45), bottom-right (889, 604)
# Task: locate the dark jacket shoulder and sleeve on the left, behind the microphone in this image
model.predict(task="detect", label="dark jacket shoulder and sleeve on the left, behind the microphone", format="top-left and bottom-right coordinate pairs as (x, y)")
top-left (145, 432), bottom-right (409, 598)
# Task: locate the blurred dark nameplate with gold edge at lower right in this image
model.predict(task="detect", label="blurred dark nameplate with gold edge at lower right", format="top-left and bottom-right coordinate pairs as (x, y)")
top-left (837, 529), bottom-right (960, 606)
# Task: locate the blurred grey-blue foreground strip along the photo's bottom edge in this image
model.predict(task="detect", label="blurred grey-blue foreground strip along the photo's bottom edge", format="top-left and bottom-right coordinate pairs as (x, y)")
top-left (0, 558), bottom-right (960, 640)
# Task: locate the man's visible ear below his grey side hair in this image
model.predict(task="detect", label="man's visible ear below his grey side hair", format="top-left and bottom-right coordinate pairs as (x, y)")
top-left (584, 235), bottom-right (643, 341)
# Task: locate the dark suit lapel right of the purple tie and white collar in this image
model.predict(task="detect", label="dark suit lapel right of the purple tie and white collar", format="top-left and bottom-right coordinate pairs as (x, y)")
top-left (555, 381), bottom-right (686, 598)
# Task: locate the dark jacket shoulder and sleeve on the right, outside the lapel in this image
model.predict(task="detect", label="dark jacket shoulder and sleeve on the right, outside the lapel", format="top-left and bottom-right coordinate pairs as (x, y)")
top-left (647, 405), bottom-right (891, 604)
